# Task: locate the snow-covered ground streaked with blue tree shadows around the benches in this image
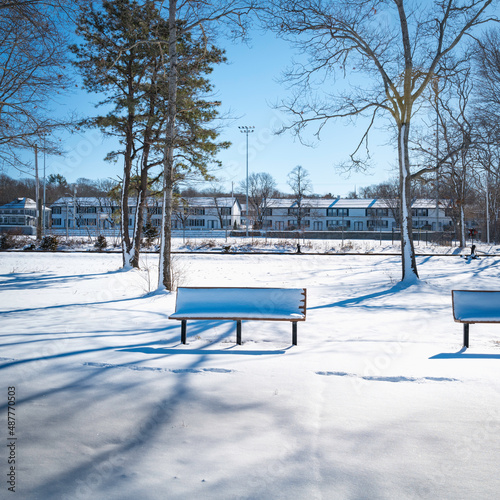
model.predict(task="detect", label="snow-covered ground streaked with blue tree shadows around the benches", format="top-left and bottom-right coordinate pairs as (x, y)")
top-left (0, 253), bottom-right (500, 500)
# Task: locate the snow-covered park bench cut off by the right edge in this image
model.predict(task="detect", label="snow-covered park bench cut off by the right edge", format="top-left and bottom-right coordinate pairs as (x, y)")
top-left (451, 290), bottom-right (500, 347)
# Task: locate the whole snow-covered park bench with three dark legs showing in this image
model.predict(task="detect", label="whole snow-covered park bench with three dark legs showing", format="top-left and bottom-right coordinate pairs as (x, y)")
top-left (169, 287), bottom-right (306, 345)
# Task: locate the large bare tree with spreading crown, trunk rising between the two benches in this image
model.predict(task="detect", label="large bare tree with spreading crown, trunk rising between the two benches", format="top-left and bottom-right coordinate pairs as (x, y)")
top-left (268, 0), bottom-right (497, 283)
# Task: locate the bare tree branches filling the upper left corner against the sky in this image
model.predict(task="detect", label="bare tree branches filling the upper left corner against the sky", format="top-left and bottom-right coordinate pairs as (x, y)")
top-left (0, 0), bottom-right (78, 172)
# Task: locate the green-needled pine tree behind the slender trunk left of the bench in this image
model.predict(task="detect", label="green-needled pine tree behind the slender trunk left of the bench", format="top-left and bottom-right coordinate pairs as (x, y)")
top-left (73, 0), bottom-right (228, 267)
